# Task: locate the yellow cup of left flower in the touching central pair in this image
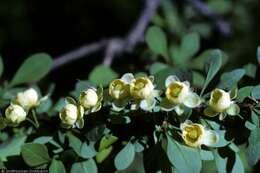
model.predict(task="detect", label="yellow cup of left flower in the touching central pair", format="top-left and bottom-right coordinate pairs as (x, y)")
top-left (109, 79), bottom-right (130, 100)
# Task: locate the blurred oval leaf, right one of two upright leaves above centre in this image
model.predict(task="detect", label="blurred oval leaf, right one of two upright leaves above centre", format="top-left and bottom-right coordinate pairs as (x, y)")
top-left (180, 32), bottom-right (200, 62)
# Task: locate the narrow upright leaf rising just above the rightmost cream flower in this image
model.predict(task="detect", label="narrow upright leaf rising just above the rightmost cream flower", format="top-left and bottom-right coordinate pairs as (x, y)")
top-left (200, 50), bottom-right (223, 95)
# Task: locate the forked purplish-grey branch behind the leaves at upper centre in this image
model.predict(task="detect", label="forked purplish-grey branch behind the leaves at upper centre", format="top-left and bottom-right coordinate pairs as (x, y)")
top-left (52, 0), bottom-right (160, 70)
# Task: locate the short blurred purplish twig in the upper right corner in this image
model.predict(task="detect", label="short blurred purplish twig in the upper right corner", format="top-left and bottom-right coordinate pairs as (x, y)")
top-left (188, 0), bottom-right (231, 35)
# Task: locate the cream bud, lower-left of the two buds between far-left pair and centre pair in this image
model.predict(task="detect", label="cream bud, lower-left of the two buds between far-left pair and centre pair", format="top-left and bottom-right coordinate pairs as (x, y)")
top-left (60, 104), bottom-right (79, 125)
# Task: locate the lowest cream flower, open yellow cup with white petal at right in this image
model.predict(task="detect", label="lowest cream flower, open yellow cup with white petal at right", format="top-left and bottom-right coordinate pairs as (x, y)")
top-left (181, 120), bottom-right (219, 147)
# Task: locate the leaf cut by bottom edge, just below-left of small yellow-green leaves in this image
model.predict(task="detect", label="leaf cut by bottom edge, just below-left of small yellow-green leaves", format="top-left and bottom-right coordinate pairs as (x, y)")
top-left (71, 159), bottom-right (98, 173)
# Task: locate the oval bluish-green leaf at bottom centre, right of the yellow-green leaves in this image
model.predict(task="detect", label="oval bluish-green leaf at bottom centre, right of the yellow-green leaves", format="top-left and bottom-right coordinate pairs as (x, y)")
top-left (115, 142), bottom-right (135, 170)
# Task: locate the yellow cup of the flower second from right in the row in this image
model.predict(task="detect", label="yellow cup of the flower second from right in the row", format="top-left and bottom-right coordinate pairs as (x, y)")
top-left (165, 81), bottom-right (189, 104)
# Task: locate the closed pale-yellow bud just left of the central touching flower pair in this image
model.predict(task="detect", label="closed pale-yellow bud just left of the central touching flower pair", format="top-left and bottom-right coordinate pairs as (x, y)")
top-left (79, 88), bottom-right (98, 109)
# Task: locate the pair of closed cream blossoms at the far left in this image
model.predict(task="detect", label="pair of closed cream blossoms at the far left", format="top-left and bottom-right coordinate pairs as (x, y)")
top-left (5, 88), bottom-right (46, 125)
